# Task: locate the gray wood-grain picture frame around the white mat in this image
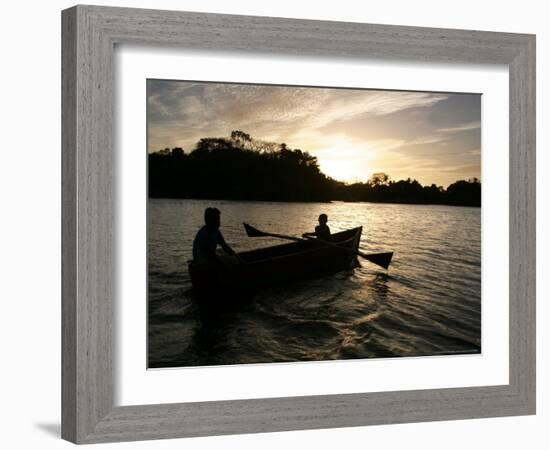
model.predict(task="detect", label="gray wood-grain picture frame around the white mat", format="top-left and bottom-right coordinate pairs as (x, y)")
top-left (62, 6), bottom-right (536, 443)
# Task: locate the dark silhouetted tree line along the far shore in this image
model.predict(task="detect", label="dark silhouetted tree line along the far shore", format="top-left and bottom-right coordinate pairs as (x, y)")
top-left (148, 130), bottom-right (481, 206)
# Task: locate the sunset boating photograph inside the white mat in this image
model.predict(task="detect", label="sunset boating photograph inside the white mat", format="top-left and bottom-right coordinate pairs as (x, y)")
top-left (147, 79), bottom-right (483, 369)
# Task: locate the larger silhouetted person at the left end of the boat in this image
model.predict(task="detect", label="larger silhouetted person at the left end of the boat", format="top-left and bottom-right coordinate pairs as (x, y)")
top-left (193, 208), bottom-right (237, 264)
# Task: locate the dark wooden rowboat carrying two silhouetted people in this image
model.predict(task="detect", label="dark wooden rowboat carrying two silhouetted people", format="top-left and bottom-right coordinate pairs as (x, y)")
top-left (188, 227), bottom-right (362, 297)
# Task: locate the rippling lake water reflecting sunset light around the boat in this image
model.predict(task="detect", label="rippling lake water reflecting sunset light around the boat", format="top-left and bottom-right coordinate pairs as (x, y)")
top-left (148, 199), bottom-right (481, 367)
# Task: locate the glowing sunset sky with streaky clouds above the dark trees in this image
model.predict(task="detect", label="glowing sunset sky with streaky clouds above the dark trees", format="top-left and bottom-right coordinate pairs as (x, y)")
top-left (147, 80), bottom-right (481, 187)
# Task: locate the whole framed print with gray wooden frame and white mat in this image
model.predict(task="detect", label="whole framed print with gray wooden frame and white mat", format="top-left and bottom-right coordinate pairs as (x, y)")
top-left (62, 6), bottom-right (535, 443)
